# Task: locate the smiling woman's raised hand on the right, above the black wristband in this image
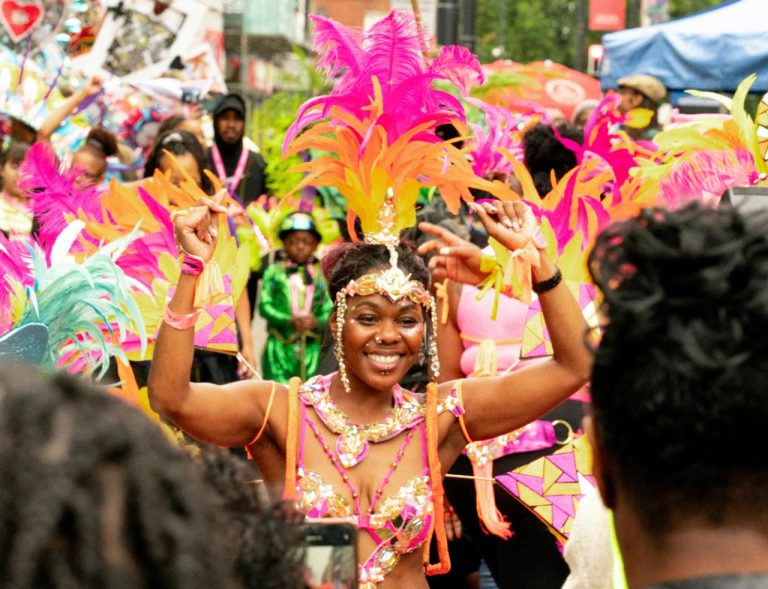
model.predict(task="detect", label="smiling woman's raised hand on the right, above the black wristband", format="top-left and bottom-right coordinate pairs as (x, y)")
top-left (470, 200), bottom-right (543, 250)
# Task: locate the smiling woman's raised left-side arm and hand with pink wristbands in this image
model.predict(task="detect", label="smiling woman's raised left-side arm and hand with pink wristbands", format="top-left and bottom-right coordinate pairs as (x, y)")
top-left (149, 188), bottom-right (281, 446)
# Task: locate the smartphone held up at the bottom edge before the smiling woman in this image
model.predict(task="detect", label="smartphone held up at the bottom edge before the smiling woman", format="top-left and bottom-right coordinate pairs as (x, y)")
top-left (301, 519), bottom-right (357, 589)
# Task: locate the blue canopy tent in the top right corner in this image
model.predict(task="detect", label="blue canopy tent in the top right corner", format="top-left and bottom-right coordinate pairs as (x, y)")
top-left (600, 0), bottom-right (768, 95)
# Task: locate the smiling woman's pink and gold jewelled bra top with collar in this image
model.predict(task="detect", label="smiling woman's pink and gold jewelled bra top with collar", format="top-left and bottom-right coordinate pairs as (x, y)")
top-left (296, 374), bottom-right (464, 589)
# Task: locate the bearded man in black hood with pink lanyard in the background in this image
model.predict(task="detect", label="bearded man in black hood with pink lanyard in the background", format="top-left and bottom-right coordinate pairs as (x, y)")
top-left (207, 94), bottom-right (267, 205)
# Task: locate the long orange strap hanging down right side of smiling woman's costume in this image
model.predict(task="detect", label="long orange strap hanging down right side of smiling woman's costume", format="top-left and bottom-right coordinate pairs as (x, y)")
top-left (424, 382), bottom-right (451, 576)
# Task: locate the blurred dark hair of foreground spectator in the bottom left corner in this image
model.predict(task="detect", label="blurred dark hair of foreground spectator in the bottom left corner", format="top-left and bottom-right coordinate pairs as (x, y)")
top-left (0, 367), bottom-right (232, 589)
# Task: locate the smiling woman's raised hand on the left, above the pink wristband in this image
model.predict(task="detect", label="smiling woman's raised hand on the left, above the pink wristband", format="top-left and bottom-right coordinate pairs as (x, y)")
top-left (172, 189), bottom-right (227, 262)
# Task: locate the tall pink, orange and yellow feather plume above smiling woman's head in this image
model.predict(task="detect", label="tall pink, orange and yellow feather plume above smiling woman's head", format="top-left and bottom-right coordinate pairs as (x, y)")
top-left (284, 11), bottom-right (512, 239)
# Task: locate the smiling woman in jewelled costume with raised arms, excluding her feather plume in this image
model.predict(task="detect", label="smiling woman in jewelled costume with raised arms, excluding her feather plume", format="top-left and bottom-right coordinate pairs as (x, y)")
top-left (150, 193), bottom-right (590, 587)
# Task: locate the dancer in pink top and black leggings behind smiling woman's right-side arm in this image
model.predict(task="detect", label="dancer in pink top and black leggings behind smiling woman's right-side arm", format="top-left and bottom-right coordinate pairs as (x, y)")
top-left (419, 223), bottom-right (584, 589)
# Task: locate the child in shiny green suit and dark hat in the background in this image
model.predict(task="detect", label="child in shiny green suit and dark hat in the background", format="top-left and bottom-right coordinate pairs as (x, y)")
top-left (259, 212), bottom-right (332, 383)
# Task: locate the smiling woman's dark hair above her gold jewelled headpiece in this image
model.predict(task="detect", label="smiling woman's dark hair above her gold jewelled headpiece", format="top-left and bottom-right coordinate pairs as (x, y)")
top-left (322, 241), bottom-right (430, 301)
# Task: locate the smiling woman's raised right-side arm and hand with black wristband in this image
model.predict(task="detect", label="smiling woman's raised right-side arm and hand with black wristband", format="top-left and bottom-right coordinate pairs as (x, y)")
top-left (438, 202), bottom-right (592, 439)
